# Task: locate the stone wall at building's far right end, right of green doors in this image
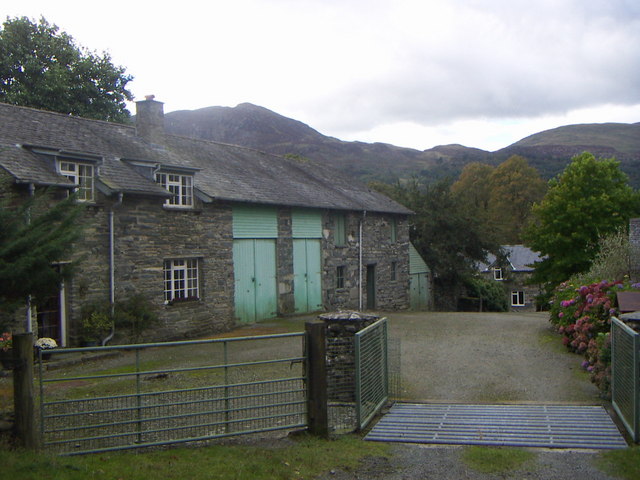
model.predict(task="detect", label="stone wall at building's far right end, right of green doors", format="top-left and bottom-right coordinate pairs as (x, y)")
top-left (322, 212), bottom-right (409, 310)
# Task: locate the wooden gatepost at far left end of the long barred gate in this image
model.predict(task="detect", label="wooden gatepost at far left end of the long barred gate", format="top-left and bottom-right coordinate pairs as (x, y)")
top-left (13, 333), bottom-right (40, 449)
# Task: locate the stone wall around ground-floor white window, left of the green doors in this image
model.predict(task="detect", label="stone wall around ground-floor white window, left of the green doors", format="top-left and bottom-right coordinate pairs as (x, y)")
top-left (68, 195), bottom-right (234, 341)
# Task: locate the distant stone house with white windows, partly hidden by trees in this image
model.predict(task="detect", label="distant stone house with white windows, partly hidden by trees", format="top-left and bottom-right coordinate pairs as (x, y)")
top-left (478, 245), bottom-right (541, 311)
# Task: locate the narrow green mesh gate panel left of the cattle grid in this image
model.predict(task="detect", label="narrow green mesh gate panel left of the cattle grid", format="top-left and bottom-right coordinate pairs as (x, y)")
top-left (355, 318), bottom-right (389, 430)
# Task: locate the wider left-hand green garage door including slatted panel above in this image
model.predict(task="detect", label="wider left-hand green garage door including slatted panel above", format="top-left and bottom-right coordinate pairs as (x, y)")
top-left (233, 206), bottom-right (278, 323)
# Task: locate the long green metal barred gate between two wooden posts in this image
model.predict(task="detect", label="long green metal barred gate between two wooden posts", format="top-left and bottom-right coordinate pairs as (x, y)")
top-left (39, 333), bottom-right (306, 455)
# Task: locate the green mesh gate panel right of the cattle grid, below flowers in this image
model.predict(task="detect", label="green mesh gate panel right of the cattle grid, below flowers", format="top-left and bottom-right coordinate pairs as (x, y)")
top-left (611, 317), bottom-right (640, 442)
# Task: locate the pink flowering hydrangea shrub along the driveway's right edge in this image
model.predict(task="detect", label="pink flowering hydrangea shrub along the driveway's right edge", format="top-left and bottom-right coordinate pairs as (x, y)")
top-left (550, 281), bottom-right (633, 397)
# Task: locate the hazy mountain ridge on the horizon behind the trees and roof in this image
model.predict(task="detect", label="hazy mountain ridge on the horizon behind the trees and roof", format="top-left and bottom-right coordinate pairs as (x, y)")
top-left (165, 103), bottom-right (640, 186)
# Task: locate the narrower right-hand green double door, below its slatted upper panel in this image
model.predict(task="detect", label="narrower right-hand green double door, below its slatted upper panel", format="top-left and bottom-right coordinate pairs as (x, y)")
top-left (293, 238), bottom-right (322, 313)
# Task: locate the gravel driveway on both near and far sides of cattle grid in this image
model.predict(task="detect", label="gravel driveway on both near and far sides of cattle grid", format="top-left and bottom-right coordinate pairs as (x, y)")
top-left (321, 313), bottom-right (624, 480)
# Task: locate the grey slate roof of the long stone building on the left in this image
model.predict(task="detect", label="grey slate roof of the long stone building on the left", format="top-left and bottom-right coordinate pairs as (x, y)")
top-left (0, 103), bottom-right (412, 214)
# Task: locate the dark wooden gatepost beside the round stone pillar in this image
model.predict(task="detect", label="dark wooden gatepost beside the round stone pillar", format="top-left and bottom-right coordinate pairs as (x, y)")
top-left (305, 321), bottom-right (329, 437)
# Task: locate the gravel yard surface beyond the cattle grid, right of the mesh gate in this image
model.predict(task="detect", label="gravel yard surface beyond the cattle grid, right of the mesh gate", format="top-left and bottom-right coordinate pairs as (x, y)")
top-left (388, 312), bottom-right (602, 404)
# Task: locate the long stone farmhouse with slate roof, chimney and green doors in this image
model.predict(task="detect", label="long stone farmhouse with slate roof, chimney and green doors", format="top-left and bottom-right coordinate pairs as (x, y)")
top-left (0, 96), bottom-right (412, 345)
